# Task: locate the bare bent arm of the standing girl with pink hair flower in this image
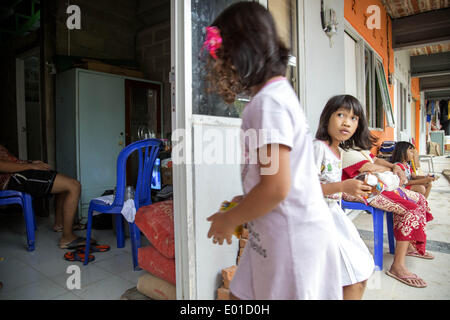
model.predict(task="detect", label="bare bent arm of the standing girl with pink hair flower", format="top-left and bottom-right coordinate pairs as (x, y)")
top-left (207, 145), bottom-right (291, 244)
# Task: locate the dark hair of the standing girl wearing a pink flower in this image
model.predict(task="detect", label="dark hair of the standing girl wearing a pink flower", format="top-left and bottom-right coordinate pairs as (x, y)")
top-left (206, 1), bottom-right (289, 103)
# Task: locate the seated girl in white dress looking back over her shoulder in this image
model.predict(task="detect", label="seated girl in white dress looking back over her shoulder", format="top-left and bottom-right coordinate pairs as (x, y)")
top-left (314, 95), bottom-right (375, 300)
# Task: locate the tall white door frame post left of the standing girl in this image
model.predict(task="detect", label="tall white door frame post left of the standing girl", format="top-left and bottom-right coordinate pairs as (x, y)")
top-left (170, 0), bottom-right (197, 300)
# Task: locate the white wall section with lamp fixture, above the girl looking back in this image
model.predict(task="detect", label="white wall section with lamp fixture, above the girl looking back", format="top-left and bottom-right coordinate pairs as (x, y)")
top-left (300, 0), bottom-right (345, 136)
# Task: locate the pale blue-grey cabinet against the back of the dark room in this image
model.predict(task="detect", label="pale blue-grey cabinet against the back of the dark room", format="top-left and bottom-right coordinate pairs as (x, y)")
top-left (56, 69), bottom-right (162, 219)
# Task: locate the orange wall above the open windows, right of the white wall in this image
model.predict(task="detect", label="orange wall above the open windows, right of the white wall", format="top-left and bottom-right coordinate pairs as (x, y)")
top-left (344, 0), bottom-right (395, 154)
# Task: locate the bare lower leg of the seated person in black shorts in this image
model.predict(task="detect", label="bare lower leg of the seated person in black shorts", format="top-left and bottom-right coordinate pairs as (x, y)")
top-left (50, 173), bottom-right (81, 244)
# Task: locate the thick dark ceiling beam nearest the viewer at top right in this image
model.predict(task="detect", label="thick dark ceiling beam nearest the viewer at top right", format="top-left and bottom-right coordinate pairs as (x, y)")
top-left (392, 8), bottom-right (450, 50)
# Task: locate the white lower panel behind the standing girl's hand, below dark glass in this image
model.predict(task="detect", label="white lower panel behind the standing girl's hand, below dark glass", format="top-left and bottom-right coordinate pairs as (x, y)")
top-left (193, 115), bottom-right (243, 300)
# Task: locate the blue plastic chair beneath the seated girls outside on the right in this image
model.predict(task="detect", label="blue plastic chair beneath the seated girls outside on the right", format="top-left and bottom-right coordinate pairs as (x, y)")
top-left (341, 200), bottom-right (395, 270)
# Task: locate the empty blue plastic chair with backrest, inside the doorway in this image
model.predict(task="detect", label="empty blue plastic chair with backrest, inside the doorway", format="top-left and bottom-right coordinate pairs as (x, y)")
top-left (84, 139), bottom-right (162, 270)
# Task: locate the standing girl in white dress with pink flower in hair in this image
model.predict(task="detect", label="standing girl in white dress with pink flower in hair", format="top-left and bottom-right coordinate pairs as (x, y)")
top-left (205, 2), bottom-right (342, 300)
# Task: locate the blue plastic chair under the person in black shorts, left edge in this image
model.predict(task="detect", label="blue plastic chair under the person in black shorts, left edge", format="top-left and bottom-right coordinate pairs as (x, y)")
top-left (0, 190), bottom-right (37, 251)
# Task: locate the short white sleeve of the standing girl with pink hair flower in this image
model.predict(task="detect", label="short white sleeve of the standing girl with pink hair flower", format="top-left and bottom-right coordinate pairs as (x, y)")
top-left (248, 95), bottom-right (295, 149)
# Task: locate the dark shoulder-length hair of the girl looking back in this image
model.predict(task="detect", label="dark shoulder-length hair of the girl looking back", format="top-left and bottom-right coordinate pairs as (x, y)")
top-left (316, 94), bottom-right (378, 150)
